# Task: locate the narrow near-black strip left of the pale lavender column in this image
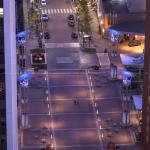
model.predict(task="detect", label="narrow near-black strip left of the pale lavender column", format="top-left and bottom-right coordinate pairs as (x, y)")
top-left (0, 1), bottom-right (7, 150)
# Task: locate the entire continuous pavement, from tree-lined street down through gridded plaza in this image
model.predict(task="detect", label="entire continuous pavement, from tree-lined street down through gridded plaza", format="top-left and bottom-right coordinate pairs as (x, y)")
top-left (19, 0), bottom-right (141, 150)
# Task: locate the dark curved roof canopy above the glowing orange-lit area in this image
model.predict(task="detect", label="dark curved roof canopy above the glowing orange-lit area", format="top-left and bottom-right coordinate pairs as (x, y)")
top-left (108, 21), bottom-right (145, 35)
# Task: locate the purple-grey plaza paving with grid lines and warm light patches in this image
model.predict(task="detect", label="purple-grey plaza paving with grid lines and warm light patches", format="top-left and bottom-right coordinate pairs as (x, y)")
top-left (22, 70), bottom-right (134, 150)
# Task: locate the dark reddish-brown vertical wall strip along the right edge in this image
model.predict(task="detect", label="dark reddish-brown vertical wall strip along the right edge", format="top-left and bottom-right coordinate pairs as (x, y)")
top-left (142, 0), bottom-right (150, 150)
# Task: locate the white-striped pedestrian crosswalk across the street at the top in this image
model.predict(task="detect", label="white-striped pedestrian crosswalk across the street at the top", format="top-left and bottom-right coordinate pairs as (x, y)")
top-left (41, 8), bottom-right (75, 15)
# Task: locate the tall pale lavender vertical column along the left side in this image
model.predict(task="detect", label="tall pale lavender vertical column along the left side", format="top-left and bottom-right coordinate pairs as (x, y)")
top-left (0, 0), bottom-right (18, 150)
